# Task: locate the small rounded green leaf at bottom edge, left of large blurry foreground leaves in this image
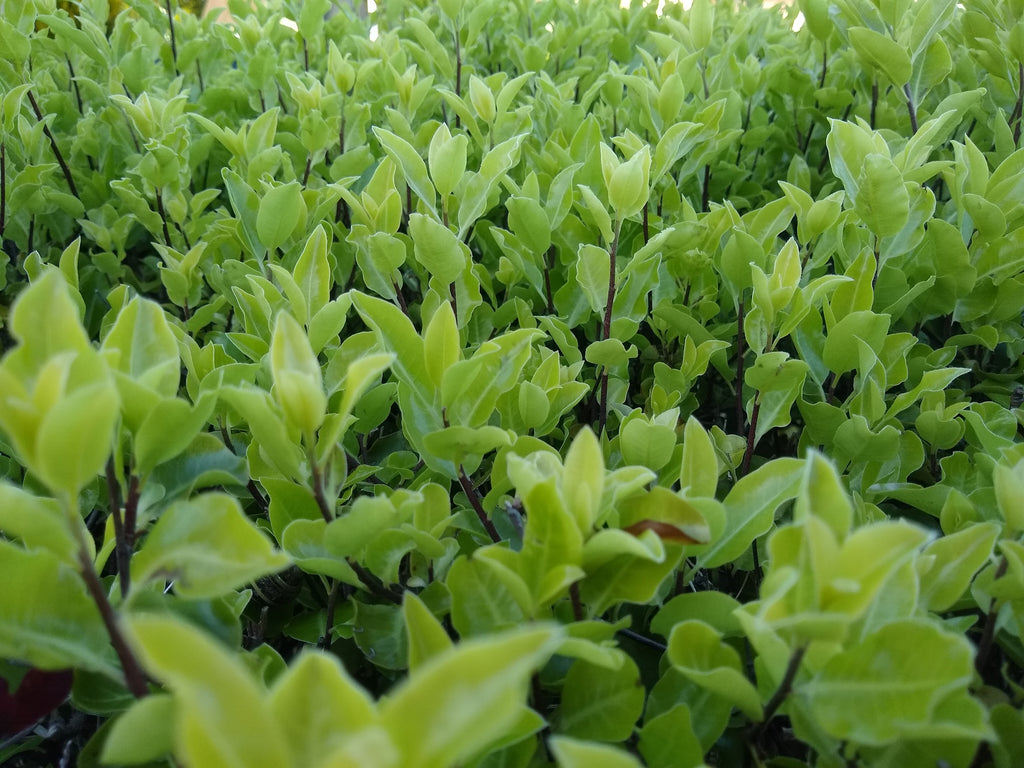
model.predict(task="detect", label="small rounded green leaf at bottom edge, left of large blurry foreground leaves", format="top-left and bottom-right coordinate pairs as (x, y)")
top-left (100, 693), bottom-right (177, 765)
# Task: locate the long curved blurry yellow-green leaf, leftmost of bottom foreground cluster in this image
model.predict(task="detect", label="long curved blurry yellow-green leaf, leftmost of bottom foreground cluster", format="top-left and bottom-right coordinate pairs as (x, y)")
top-left (128, 614), bottom-right (289, 768)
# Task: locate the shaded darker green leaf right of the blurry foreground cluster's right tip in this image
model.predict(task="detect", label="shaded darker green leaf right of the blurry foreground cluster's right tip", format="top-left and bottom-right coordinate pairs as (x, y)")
top-left (555, 654), bottom-right (644, 741)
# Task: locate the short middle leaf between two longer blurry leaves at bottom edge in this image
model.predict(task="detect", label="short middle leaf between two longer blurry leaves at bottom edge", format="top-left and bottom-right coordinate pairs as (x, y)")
top-left (267, 650), bottom-right (382, 766)
